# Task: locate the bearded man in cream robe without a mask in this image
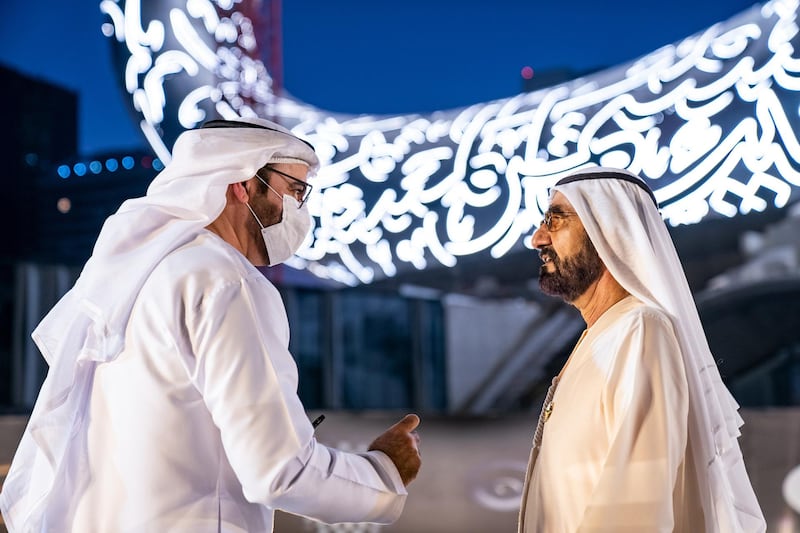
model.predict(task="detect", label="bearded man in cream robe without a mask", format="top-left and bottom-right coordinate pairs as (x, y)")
top-left (519, 168), bottom-right (766, 533)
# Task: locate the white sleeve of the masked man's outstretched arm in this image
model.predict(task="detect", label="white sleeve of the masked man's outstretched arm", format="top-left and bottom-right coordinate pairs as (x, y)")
top-left (186, 279), bottom-right (406, 523)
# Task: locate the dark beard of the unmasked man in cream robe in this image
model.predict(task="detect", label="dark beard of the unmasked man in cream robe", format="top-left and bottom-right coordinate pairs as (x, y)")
top-left (539, 233), bottom-right (603, 302)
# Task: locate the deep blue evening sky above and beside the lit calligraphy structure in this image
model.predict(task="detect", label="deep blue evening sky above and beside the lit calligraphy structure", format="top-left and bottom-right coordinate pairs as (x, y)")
top-left (0, 0), bottom-right (754, 155)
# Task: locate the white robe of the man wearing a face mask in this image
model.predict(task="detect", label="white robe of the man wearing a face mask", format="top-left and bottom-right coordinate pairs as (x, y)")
top-left (0, 230), bottom-right (406, 533)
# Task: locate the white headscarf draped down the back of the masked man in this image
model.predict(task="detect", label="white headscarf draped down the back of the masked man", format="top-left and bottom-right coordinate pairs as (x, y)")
top-left (0, 119), bottom-right (319, 531)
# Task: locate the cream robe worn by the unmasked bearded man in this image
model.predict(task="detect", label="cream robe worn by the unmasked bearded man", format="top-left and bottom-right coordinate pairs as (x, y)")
top-left (520, 296), bottom-right (704, 533)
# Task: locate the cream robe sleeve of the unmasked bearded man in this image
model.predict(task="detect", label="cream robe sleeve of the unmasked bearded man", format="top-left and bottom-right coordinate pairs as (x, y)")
top-left (578, 311), bottom-right (688, 533)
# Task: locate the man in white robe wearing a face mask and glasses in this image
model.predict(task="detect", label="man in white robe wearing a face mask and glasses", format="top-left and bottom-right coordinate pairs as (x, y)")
top-left (0, 119), bottom-right (420, 533)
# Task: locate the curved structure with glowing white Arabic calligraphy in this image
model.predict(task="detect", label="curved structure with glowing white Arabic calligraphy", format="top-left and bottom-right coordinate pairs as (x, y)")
top-left (101, 0), bottom-right (800, 285)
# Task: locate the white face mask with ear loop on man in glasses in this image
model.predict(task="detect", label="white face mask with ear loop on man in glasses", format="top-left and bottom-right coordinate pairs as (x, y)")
top-left (246, 187), bottom-right (311, 266)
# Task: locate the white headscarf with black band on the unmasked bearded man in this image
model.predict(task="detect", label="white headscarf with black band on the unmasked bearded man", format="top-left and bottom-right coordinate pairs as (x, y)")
top-left (554, 167), bottom-right (766, 533)
